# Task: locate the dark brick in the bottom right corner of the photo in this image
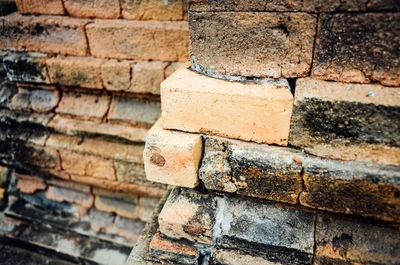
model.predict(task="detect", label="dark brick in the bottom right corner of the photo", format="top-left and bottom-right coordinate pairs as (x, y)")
top-left (315, 214), bottom-right (400, 265)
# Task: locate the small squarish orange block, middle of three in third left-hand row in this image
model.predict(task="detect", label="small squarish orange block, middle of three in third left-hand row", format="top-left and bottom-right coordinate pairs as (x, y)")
top-left (101, 60), bottom-right (131, 91)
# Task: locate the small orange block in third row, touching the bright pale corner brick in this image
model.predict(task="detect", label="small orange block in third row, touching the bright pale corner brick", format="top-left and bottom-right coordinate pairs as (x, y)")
top-left (129, 62), bottom-right (167, 95)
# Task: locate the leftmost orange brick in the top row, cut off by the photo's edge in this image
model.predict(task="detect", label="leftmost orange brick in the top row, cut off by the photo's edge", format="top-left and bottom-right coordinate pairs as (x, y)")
top-left (15, 0), bottom-right (65, 15)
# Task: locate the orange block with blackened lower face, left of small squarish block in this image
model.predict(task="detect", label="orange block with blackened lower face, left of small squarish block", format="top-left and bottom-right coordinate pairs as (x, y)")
top-left (47, 56), bottom-right (103, 89)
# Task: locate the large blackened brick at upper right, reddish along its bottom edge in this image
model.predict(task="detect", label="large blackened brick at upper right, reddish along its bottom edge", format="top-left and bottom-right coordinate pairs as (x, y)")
top-left (312, 13), bottom-right (400, 86)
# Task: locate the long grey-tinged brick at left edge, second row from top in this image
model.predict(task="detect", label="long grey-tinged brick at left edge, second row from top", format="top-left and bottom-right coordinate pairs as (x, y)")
top-left (0, 13), bottom-right (87, 56)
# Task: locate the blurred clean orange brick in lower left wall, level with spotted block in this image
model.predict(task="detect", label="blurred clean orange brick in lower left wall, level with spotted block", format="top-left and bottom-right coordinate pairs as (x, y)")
top-left (59, 150), bottom-right (116, 180)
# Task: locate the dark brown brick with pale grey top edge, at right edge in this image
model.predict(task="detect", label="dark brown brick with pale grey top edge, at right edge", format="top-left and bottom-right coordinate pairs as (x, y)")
top-left (300, 157), bottom-right (400, 222)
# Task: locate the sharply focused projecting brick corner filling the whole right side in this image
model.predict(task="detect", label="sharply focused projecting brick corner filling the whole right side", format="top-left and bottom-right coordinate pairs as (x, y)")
top-left (134, 0), bottom-right (400, 265)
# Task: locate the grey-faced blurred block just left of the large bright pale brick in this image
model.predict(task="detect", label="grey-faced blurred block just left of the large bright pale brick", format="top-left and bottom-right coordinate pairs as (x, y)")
top-left (108, 96), bottom-right (161, 126)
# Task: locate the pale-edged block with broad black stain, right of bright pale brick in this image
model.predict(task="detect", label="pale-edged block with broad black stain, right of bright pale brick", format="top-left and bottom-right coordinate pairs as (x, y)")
top-left (289, 78), bottom-right (400, 165)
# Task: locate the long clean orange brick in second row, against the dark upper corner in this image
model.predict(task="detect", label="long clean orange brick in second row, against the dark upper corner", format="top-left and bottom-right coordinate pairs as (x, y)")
top-left (86, 20), bottom-right (189, 61)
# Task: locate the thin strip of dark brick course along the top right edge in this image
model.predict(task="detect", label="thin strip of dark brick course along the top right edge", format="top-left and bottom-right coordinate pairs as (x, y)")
top-left (188, 0), bottom-right (400, 13)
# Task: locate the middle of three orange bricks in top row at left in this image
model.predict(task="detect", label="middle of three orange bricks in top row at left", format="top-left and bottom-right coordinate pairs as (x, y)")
top-left (64, 0), bottom-right (120, 19)
